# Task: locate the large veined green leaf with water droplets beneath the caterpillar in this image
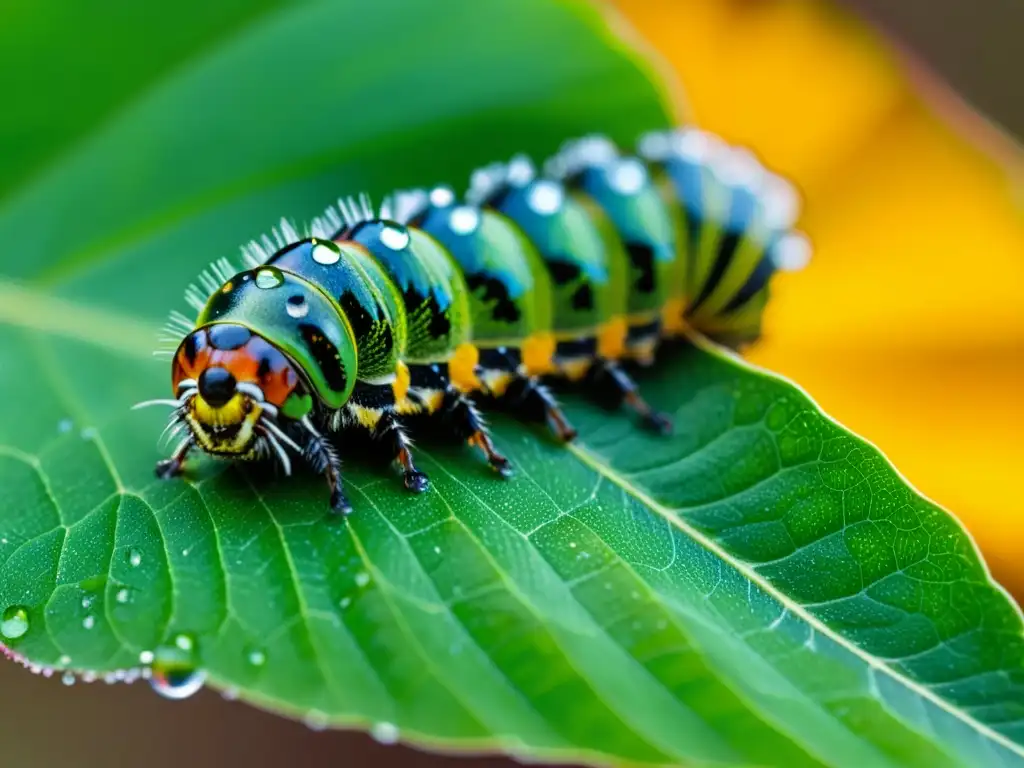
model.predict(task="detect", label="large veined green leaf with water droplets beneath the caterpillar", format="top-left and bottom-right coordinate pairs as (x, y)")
top-left (0, 0), bottom-right (1024, 767)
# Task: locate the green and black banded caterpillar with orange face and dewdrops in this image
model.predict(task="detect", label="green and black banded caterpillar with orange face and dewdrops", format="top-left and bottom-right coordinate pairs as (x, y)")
top-left (136, 128), bottom-right (809, 513)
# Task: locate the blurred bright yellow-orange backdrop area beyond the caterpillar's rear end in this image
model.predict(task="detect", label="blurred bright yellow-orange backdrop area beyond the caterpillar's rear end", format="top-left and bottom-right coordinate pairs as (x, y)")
top-left (613, 0), bottom-right (1024, 599)
